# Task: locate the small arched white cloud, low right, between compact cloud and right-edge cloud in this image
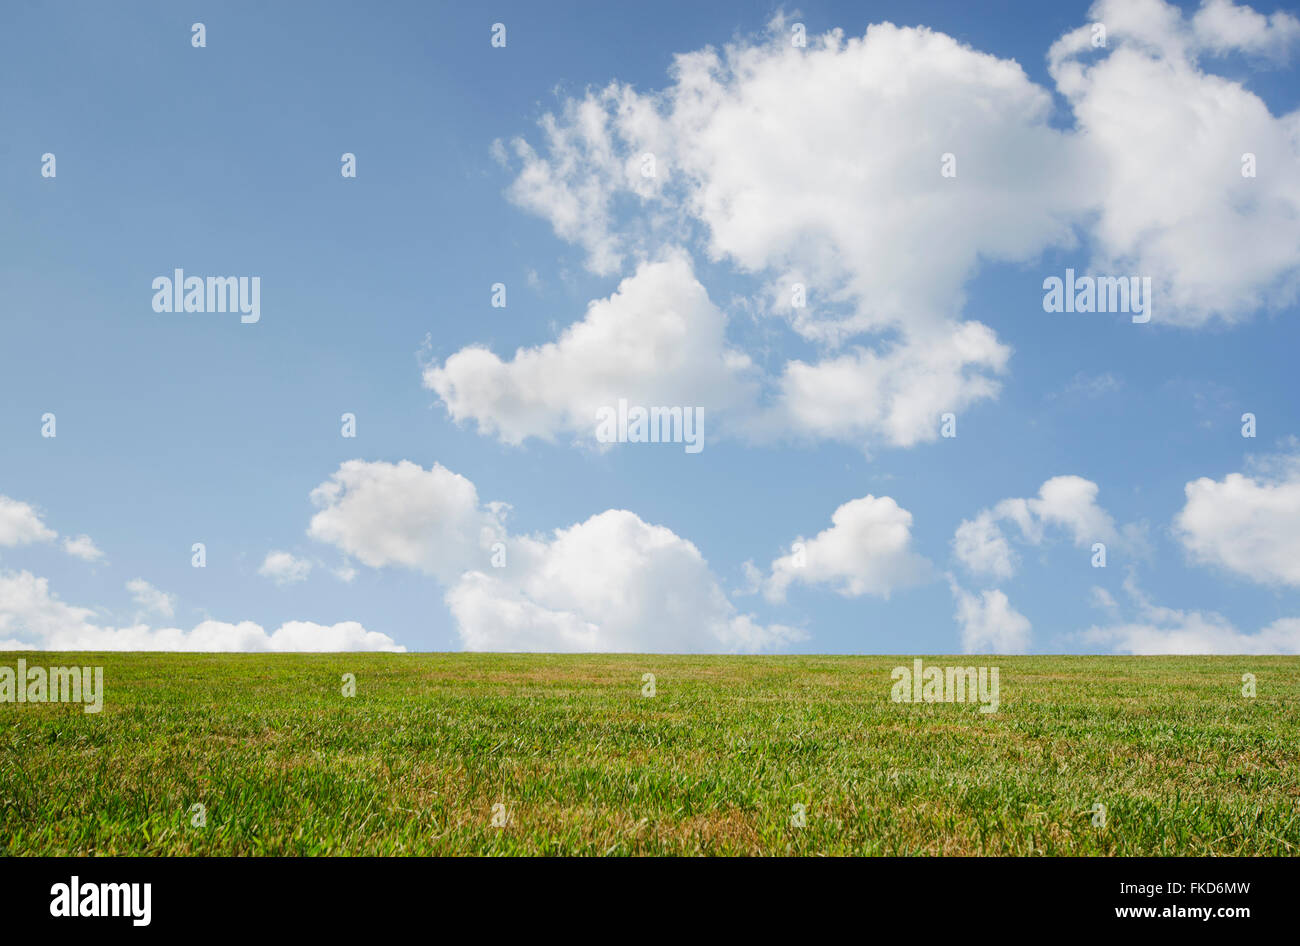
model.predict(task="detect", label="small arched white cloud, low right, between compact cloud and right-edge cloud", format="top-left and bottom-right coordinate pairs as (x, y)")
top-left (953, 476), bottom-right (1143, 578)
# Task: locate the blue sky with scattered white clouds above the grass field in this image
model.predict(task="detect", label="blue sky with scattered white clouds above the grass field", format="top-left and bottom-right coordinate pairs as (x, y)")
top-left (0, 0), bottom-right (1300, 654)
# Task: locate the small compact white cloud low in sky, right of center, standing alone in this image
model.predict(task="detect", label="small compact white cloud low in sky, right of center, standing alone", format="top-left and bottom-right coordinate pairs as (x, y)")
top-left (763, 495), bottom-right (931, 602)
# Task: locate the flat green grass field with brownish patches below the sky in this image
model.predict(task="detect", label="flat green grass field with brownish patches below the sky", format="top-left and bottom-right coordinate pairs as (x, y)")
top-left (0, 652), bottom-right (1300, 855)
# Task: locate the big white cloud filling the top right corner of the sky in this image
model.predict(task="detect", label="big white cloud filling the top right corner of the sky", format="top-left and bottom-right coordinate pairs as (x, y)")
top-left (1049, 0), bottom-right (1300, 325)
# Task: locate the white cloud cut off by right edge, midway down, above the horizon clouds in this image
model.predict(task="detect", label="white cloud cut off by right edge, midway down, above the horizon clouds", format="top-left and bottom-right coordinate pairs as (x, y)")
top-left (1174, 455), bottom-right (1300, 587)
